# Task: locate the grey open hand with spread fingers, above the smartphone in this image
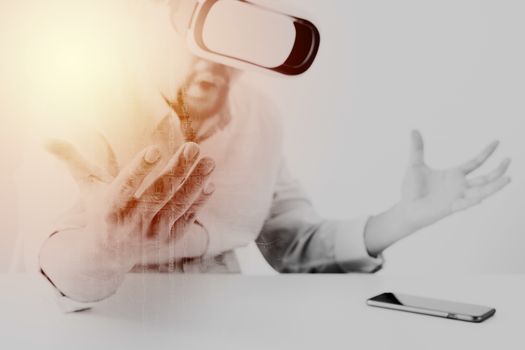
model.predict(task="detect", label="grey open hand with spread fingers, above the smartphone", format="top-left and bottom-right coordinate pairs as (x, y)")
top-left (402, 131), bottom-right (510, 228)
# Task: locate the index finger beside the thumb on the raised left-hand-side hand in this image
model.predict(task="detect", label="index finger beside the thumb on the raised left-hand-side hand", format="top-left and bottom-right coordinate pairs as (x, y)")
top-left (113, 146), bottom-right (160, 208)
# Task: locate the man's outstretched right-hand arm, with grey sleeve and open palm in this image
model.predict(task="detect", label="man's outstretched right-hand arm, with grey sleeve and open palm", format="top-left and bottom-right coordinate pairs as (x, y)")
top-left (257, 131), bottom-right (510, 272)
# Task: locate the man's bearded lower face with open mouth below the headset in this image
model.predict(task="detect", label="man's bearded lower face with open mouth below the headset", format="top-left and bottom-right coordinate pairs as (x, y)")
top-left (182, 57), bottom-right (236, 118)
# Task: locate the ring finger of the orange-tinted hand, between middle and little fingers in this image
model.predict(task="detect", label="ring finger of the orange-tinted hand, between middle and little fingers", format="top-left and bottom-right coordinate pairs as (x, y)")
top-left (162, 158), bottom-right (215, 220)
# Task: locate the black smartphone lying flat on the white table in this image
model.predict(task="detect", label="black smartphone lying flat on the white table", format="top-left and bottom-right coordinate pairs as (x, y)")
top-left (366, 293), bottom-right (496, 322)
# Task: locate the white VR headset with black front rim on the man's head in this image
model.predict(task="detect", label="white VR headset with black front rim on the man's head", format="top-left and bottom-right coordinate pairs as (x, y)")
top-left (171, 0), bottom-right (320, 75)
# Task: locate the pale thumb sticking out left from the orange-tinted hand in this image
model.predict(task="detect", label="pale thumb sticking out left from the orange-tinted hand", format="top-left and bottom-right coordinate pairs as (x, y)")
top-left (45, 140), bottom-right (112, 184)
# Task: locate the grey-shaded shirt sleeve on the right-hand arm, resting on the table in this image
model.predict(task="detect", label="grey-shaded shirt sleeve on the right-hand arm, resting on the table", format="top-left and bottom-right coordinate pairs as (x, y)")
top-left (257, 164), bottom-right (383, 273)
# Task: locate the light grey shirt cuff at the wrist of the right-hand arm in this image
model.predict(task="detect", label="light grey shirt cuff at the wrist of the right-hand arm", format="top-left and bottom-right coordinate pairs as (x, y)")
top-left (334, 216), bottom-right (384, 273)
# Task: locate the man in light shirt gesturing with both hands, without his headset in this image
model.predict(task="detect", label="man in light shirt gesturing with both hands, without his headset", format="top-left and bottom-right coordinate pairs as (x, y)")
top-left (40, 4), bottom-right (510, 302)
